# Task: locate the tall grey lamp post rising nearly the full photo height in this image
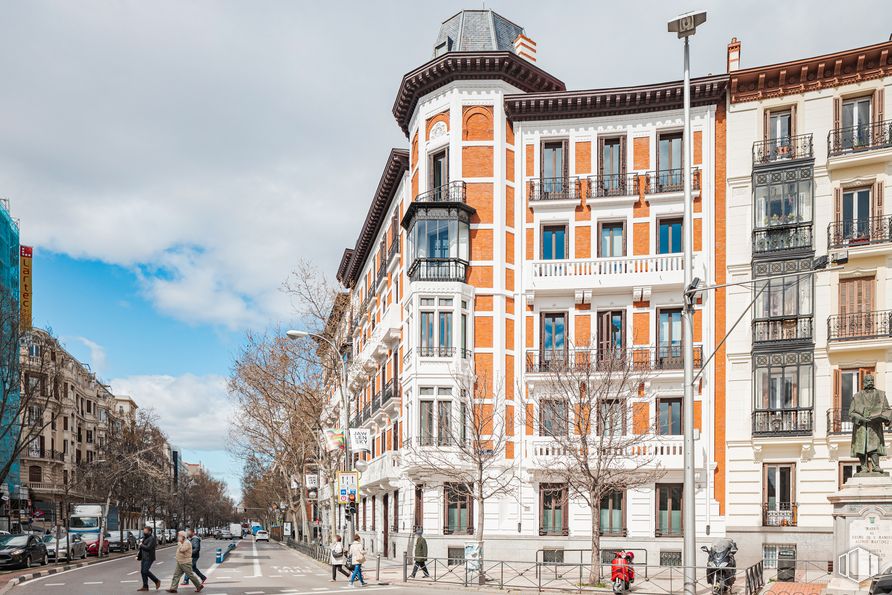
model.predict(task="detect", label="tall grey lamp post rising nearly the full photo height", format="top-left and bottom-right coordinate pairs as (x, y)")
top-left (668, 11), bottom-right (706, 595)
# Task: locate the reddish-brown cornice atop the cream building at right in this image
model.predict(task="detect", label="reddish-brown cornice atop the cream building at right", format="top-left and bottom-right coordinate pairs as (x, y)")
top-left (729, 41), bottom-right (892, 103)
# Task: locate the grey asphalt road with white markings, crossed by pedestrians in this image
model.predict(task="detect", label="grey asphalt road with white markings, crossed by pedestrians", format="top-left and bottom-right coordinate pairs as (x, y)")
top-left (10, 538), bottom-right (429, 595)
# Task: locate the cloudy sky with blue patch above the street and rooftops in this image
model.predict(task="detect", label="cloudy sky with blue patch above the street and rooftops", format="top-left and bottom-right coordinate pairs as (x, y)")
top-left (0, 0), bottom-right (892, 497)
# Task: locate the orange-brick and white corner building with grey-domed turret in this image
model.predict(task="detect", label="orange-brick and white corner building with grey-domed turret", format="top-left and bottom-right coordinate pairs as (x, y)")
top-left (332, 10), bottom-right (727, 564)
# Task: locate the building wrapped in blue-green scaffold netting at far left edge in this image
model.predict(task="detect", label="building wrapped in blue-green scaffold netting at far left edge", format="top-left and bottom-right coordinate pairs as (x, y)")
top-left (0, 199), bottom-right (21, 502)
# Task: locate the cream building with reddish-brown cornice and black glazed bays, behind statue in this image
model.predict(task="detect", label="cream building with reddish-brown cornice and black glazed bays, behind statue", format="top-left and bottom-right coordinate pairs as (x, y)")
top-left (727, 39), bottom-right (892, 565)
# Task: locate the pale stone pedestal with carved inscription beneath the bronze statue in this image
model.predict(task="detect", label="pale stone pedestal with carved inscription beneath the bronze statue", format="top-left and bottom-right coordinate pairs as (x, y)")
top-left (825, 474), bottom-right (892, 595)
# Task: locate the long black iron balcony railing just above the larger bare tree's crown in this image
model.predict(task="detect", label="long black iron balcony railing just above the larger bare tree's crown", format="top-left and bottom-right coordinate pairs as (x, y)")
top-left (526, 345), bottom-right (703, 374)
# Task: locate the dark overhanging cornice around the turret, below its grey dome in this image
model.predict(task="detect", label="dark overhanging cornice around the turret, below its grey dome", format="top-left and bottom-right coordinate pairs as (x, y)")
top-left (393, 51), bottom-right (566, 137)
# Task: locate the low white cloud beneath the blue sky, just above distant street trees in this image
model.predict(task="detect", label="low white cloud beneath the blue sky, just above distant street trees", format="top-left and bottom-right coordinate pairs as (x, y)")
top-left (109, 374), bottom-right (233, 451)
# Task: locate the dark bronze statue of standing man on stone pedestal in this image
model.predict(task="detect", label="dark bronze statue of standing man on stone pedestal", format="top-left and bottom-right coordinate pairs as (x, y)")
top-left (849, 374), bottom-right (892, 475)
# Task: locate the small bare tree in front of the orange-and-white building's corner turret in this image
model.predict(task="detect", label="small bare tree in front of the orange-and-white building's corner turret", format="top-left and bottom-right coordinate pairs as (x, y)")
top-left (407, 364), bottom-right (516, 560)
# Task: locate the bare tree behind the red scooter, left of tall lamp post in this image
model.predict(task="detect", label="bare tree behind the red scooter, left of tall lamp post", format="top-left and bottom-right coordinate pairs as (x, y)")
top-left (527, 345), bottom-right (663, 583)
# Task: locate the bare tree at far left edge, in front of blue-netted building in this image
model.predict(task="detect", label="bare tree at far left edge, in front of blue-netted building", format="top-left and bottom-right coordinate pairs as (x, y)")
top-left (0, 312), bottom-right (70, 494)
